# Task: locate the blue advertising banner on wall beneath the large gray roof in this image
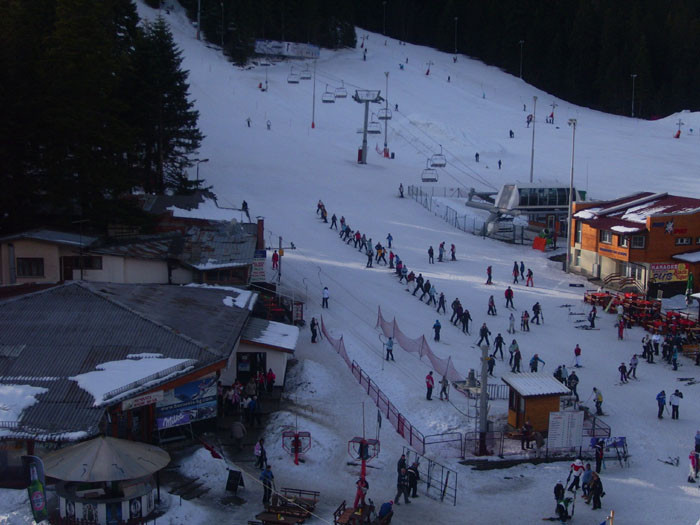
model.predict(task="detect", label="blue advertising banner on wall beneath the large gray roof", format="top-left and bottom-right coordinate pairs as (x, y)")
top-left (156, 374), bottom-right (216, 430)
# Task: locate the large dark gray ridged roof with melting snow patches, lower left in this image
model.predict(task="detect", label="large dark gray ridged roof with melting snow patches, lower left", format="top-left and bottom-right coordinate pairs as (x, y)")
top-left (0, 283), bottom-right (249, 440)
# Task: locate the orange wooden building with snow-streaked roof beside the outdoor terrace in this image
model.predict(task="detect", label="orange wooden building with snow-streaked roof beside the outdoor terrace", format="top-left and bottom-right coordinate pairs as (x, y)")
top-left (570, 192), bottom-right (700, 297)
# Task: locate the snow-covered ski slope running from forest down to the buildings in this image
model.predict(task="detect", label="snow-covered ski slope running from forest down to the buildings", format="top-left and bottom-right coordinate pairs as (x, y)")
top-left (146, 5), bottom-right (700, 524)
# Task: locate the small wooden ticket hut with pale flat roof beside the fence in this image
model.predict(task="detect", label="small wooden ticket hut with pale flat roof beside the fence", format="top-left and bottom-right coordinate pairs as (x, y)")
top-left (501, 373), bottom-right (571, 432)
